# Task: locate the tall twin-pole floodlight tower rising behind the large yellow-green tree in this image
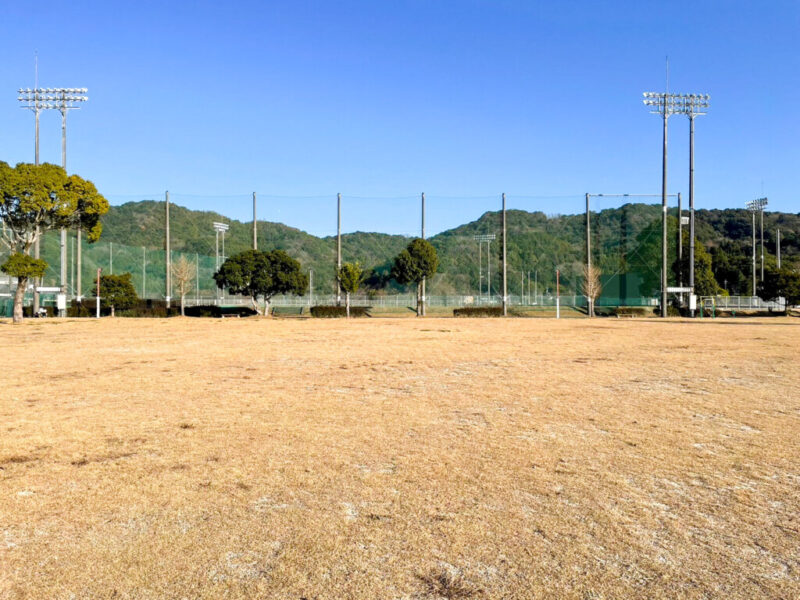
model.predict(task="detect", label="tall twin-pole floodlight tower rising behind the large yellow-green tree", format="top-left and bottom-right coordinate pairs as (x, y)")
top-left (17, 85), bottom-right (89, 316)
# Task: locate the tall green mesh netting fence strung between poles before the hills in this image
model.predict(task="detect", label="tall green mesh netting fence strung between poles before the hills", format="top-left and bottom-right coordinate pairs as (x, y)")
top-left (0, 194), bottom-right (700, 314)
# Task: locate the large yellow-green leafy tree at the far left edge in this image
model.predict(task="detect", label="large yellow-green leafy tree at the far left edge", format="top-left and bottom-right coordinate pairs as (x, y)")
top-left (0, 161), bottom-right (108, 323)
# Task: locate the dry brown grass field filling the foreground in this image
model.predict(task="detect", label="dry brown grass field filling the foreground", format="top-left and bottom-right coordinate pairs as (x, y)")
top-left (0, 318), bottom-right (800, 600)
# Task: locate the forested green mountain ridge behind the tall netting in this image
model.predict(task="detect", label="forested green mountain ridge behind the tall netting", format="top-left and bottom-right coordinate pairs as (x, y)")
top-left (32, 200), bottom-right (800, 295)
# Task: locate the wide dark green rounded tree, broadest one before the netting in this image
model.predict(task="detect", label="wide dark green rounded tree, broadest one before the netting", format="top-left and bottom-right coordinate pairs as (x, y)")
top-left (214, 250), bottom-right (308, 315)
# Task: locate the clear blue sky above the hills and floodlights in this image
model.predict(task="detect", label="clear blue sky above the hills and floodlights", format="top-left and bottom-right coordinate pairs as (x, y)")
top-left (0, 0), bottom-right (800, 233)
